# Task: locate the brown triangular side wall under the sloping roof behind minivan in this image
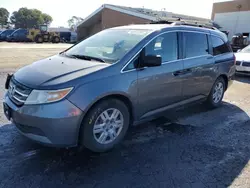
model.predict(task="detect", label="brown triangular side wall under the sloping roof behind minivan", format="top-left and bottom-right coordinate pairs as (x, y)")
top-left (102, 9), bottom-right (150, 29)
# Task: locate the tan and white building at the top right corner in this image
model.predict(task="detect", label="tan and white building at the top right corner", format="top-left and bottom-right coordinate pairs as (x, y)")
top-left (212, 0), bottom-right (250, 39)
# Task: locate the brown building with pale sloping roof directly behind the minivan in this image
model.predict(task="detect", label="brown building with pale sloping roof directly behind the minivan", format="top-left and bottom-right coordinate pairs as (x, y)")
top-left (77, 4), bottom-right (210, 40)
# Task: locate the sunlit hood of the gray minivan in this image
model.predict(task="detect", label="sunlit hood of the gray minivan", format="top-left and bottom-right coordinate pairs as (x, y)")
top-left (14, 55), bottom-right (110, 88)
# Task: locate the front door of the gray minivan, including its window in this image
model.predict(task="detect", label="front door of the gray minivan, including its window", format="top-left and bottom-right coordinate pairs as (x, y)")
top-left (137, 32), bottom-right (183, 118)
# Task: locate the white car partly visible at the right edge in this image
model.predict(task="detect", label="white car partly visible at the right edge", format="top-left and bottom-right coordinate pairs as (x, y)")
top-left (235, 45), bottom-right (250, 74)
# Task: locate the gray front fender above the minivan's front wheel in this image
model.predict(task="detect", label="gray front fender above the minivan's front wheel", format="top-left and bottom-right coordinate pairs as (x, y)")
top-left (68, 71), bottom-right (137, 117)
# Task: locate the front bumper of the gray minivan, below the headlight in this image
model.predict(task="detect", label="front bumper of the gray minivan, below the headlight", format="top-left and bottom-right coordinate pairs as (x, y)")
top-left (4, 95), bottom-right (83, 147)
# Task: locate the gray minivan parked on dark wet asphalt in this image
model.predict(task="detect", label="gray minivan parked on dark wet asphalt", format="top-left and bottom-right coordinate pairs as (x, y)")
top-left (3, 24), bottom-right (235, 152)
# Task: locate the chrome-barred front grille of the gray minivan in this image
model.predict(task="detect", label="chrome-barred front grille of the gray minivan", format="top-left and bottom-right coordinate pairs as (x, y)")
top-left (8, 78), bottom-right (32, 106)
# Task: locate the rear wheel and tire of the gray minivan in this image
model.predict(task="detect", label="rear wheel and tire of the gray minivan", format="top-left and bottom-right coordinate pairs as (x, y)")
top-left (207, 77), bottom-right (226, 108)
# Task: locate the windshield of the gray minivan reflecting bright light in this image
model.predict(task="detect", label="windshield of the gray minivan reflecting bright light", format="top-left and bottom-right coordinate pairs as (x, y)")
top-left (65, 29), bottom-right (151, 63)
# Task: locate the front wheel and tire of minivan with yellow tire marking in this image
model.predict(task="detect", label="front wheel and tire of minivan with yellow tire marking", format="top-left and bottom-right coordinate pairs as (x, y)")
top-left (80, 99), bottom-right (130, 152)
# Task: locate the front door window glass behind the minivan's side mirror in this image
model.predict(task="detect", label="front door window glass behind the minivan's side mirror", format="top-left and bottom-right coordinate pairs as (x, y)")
top-left (145, 32), bottom-right (178, 63)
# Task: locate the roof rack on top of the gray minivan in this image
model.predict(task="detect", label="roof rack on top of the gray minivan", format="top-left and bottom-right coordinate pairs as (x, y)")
top-left (150, 18), bottom-right (218, 30)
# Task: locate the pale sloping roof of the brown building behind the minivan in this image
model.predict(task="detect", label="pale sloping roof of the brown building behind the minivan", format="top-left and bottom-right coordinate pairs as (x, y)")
top-left (79, 4), bottom-right (211, 25)
